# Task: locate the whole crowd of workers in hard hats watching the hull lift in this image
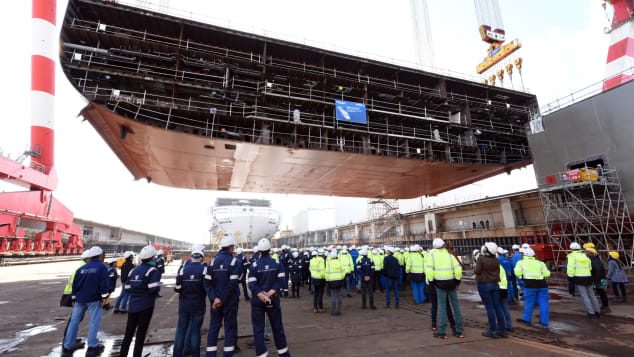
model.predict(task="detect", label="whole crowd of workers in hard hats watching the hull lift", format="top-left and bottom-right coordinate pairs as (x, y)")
top-left (62, 236), bottom-right (627, 357)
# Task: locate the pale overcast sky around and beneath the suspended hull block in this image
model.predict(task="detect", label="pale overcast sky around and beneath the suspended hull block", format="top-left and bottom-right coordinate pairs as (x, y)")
top-left (0, 0), bottom-right (609, 242)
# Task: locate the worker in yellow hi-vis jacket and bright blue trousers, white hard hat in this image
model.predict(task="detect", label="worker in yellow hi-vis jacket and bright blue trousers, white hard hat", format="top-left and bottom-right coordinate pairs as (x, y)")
top-left (515, 248), bottom-right (550, 327)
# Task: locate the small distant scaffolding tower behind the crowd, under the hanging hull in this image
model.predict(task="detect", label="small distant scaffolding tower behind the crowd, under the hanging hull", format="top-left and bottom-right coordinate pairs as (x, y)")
top-left (368, 198), bottom-right (403, 243)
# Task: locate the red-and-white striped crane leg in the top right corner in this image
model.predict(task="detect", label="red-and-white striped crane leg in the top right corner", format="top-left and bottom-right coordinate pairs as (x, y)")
top-left (603, 0), bottom-right (634, 90)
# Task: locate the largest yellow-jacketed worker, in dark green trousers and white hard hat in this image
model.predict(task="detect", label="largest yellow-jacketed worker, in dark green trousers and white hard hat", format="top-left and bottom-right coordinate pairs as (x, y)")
top-left (425, 238), bottom-right (464, 339)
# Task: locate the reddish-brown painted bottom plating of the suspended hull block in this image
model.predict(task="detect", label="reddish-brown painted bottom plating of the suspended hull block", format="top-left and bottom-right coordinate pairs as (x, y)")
top-left (82, 103), bottom-right (529, 198)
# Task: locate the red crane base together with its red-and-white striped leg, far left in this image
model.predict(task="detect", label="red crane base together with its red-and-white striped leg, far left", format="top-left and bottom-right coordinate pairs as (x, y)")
top-left (0, 0), bottom-right (83, 256)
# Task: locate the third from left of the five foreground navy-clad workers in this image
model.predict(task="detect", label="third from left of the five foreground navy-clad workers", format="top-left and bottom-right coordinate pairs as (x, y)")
top-left (173, 244), bottom-right (207, 357)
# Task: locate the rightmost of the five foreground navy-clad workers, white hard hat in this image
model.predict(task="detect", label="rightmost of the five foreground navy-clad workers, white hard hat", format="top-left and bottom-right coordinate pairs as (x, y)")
top-left (248, 238), bottom-right (291, 357)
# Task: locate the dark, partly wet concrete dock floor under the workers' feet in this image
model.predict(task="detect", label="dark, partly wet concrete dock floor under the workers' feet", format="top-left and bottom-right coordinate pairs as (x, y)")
top-left (0, 263), bottom-right (634, 357)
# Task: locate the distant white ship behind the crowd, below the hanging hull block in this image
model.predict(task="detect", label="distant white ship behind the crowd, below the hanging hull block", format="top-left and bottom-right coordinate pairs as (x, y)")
top-left (211, 198), bottom-right (281, 247)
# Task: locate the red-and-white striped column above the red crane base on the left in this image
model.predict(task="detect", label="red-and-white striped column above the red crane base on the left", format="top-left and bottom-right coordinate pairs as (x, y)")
top-left (31, 0), bottom-right (58, 174)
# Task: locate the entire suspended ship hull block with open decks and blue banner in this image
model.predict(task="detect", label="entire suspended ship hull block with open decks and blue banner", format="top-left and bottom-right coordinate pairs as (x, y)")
top-left (60, 0), bottom-right (537, 198)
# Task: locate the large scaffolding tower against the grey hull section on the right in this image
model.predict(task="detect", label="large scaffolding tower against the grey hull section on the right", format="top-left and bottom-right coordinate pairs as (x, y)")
top-left (538, 167), bottom-right (634, 266)
